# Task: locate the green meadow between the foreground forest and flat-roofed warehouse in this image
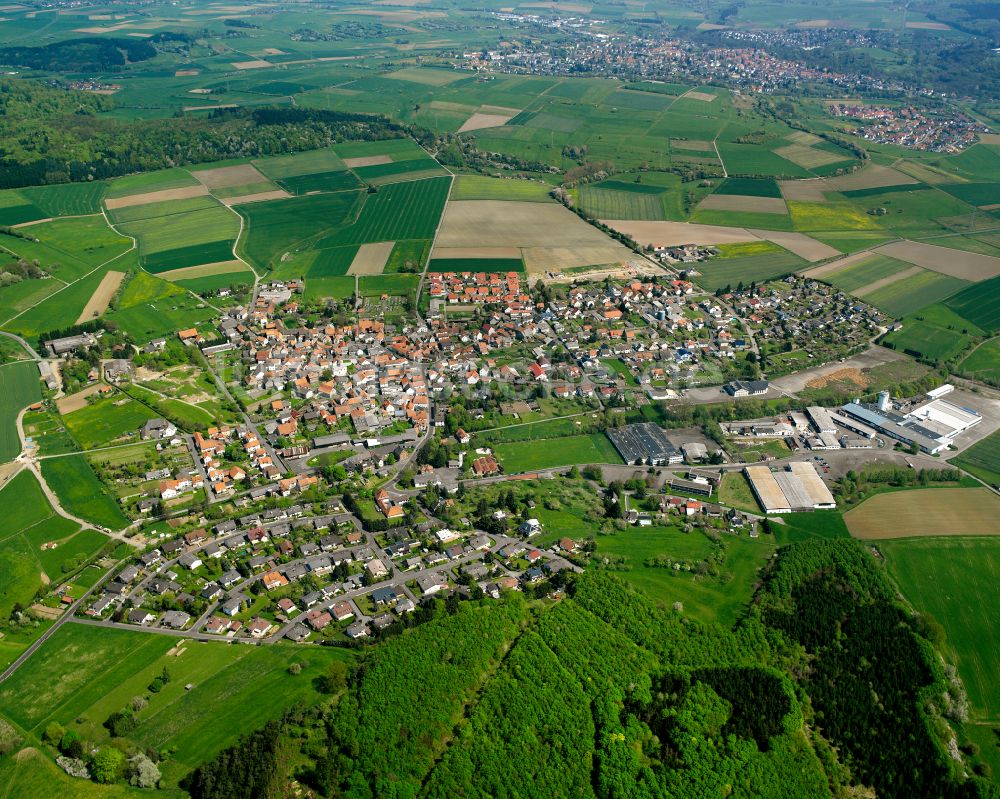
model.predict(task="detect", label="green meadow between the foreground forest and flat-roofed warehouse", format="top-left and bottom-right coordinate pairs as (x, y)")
top-left (597, 527), bottom-right (775, 626)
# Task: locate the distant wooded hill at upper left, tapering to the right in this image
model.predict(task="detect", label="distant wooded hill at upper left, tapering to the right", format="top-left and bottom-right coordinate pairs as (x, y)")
top-left (0, 78), bottom-right (405, 188)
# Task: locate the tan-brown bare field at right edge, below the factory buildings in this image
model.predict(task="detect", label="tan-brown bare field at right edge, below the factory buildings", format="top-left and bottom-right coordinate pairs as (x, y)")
top-left (844, 488), bottom-right (1000, 541)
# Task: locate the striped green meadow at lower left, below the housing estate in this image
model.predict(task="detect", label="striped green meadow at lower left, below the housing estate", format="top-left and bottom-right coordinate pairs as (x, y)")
top-left (0, 624), bottom-right (352, 784)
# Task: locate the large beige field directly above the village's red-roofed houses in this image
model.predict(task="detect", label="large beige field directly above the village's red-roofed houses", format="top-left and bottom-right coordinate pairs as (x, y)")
top-left (431, 200), bottom-right (634, 274)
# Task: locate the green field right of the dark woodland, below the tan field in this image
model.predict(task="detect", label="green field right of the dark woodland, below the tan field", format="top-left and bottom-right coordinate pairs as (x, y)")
top-left (879, 538), bottom-right (1000, 722)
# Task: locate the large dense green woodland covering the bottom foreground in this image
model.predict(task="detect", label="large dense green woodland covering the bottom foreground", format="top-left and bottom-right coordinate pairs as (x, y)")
top-left (185, 540), bottom-right (1000, 799)
